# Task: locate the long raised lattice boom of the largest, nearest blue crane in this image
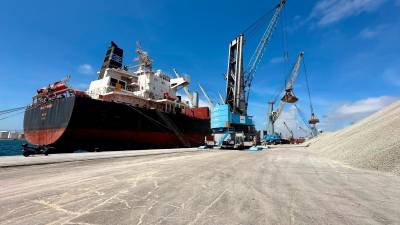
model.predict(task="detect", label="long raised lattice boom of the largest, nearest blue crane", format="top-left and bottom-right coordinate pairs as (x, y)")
top-left (245, 0), bottom-right (287, 106)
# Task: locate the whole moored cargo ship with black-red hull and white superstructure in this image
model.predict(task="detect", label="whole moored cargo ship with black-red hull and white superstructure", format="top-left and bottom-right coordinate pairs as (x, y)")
top-left (24, 42), bottom-right (210, 153)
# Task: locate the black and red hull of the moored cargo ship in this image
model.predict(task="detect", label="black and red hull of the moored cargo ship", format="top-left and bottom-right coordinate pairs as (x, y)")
top-left (24, 96), bottom-right (210, 153)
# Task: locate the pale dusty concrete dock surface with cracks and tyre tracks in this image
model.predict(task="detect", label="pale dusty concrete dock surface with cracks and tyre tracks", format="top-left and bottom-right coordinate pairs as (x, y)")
top-left (0, 147), bottom-right (400, 225)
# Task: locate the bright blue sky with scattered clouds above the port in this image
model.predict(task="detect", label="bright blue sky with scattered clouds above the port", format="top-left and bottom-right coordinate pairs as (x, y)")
top-left (0, 0), bottom-right (400, 135)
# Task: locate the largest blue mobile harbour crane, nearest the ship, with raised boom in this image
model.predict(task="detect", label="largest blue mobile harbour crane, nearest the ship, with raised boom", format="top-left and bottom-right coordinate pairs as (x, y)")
top-left (211, 0), bottom-right (287, 148)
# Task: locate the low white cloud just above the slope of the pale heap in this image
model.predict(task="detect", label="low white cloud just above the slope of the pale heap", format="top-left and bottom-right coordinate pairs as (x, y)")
top-left (320, 96), bottom-right (399, 130)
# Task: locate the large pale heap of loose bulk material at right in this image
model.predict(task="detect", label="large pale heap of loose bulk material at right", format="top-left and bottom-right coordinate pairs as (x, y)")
top-left (308, 101), bottom-right (400, 175)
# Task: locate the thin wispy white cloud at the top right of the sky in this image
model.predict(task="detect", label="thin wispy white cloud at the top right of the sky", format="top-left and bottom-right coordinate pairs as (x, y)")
top-left (309, 0), bottom-right (386, 26)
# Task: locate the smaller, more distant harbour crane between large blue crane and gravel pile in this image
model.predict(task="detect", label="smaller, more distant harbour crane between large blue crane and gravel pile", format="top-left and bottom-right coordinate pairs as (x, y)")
top-left (264, 52), bottom-right (304, 143)
